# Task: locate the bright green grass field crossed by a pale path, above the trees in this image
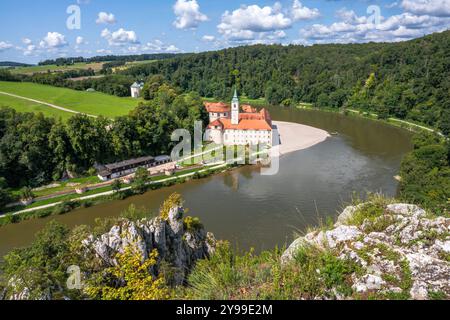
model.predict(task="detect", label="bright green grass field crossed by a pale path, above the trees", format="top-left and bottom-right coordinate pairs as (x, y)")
top-left (0, 81), bottom-right (138, 119)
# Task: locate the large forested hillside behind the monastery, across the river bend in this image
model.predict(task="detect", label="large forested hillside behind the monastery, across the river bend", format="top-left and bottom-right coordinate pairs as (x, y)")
top-left (124, 31), bottom-right (450, 133)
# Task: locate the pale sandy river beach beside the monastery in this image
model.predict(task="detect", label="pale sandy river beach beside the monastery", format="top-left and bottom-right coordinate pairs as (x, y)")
top-left (273, 121), bottom-right (330, 155)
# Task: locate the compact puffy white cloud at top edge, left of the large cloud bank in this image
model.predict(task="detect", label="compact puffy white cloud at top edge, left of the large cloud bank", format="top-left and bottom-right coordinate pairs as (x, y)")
top-left (173, 0), bottom-right (208, 29)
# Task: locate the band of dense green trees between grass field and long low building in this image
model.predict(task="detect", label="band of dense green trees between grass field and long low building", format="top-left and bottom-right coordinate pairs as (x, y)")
top-left (0, 85), bottom-right (207, 205)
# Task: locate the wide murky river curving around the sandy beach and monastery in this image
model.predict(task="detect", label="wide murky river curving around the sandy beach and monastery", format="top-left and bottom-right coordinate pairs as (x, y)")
top-left (0, 108), bottom-right (411, 255)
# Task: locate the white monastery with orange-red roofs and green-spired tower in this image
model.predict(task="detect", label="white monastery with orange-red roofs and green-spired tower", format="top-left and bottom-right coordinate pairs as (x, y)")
top-left (205, 90), bottom-right (273, 146)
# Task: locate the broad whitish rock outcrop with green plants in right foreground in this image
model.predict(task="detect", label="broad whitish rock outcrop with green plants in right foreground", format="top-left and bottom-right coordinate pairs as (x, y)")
top-left (282, 203), bottom-right (450, 299)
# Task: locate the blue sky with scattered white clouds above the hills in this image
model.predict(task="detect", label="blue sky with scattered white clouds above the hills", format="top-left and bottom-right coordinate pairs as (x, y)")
top-left (0, 0), bottom-right (450, 63)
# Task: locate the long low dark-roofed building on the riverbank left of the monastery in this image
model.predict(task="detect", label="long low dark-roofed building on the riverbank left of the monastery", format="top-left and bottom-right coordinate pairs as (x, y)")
top-left (98, 156), bottom-right (171, 181)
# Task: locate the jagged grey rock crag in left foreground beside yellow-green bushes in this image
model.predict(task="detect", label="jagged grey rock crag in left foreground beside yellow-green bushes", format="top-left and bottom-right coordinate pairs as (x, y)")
top-left (83, 207), bottom-right (216, 285)
